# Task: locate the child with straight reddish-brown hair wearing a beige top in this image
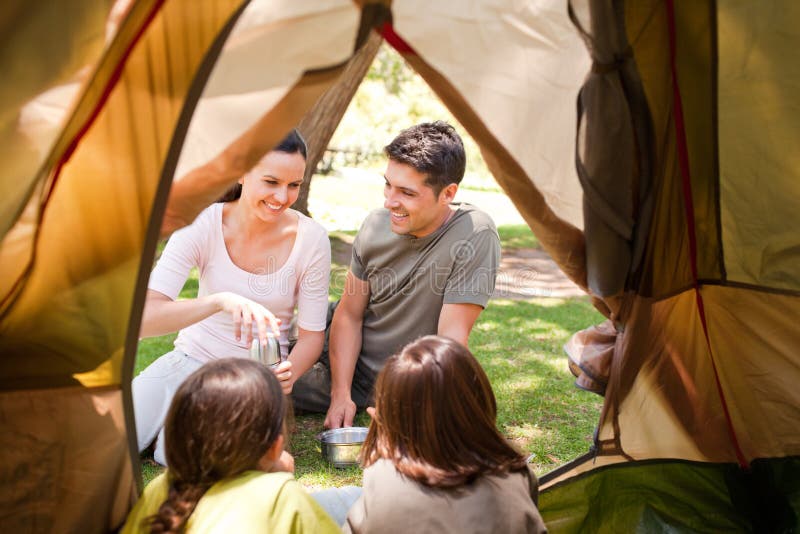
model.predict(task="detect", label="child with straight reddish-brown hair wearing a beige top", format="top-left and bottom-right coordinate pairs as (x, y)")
top-left (344, 336), bottom-right (546, 533)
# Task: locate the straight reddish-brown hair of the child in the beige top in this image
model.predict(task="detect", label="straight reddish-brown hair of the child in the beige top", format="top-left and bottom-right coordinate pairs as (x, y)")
top-left (361, 336), bottom-right (527, 488)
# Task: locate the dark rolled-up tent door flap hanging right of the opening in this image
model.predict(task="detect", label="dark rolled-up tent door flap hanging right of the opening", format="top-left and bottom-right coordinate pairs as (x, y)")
top-left (568, 2), bottom-right (652, 297)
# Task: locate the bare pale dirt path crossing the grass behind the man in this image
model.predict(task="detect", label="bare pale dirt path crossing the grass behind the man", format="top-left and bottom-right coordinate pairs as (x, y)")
top-left (331, 234), bottom-right (585, 299)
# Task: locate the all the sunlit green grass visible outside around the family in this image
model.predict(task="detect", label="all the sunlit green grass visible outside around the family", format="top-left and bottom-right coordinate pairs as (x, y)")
top-left (136, 226), bottom-right (602, 489)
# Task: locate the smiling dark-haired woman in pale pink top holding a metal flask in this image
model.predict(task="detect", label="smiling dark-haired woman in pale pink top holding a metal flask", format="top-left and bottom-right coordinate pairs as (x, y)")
top-left (133, 130), bottom-right (330, 464)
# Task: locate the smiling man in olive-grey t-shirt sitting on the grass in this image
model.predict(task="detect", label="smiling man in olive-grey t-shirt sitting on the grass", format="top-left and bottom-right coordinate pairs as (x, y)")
top-left (292, 121), bottom-right (500, 428)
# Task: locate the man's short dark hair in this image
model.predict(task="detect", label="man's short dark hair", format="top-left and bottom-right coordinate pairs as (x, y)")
top-left (383, 121), bottom-right (467, 195)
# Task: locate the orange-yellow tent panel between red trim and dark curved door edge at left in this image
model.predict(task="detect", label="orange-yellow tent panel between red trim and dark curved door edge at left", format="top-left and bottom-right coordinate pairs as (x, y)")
top-left (0, 0), bottom-right (250, 389)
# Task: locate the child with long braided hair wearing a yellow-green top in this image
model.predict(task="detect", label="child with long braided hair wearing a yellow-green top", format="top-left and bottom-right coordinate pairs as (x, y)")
top-left (122, 358), bottom-right (340, 534)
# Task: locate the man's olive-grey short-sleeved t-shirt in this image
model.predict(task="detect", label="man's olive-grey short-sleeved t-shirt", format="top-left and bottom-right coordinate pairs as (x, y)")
top-left (350, 203), bottom-right (500, 378)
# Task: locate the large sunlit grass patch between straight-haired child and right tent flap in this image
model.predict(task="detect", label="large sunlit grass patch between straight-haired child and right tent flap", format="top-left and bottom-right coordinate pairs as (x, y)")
top-left (470, 298), bottom-right (602, 474)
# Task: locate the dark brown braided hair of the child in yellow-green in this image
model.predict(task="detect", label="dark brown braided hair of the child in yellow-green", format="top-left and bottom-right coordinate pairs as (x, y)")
top-left (145, 358), bottom-right (285, 532)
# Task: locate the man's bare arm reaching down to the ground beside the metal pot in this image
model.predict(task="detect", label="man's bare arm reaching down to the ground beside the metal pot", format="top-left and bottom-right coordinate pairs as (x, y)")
top-left (325, 271), bottom-right (369, 428)
